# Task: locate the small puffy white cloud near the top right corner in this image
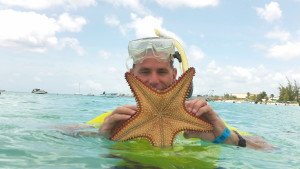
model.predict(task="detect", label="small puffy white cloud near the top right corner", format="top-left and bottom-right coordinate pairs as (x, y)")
top-left (256, 2), bottom-right (282, 22)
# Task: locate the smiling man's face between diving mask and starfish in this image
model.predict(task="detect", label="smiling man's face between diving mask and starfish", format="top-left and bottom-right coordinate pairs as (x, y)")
top-left (130, 58), bottom-right (177, 90)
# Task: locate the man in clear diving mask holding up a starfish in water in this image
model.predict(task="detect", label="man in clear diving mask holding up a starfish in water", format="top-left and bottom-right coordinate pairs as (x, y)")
top-left (99, 38), bottom-right (272, 149)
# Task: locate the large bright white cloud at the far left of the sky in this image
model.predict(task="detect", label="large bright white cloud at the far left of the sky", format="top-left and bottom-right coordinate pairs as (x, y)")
top-left (0, 10), bottom-right (86, 54)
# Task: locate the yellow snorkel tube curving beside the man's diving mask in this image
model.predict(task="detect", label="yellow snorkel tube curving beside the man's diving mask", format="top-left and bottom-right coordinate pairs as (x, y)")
top-left (154, 28), bottom-right (189, 74)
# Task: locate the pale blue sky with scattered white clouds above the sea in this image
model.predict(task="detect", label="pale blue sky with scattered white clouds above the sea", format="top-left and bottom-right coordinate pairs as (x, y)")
top-left (0, 0), bottom-right (300, 96)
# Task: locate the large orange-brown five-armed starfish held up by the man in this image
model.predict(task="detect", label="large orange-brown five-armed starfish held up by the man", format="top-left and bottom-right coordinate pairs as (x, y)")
top-left (110, 68), bottom-right (212, 147)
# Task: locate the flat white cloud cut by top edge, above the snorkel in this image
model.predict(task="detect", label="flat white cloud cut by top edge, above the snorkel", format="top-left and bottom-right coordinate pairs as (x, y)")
top-left (155, 0), bottom-right (219, 8)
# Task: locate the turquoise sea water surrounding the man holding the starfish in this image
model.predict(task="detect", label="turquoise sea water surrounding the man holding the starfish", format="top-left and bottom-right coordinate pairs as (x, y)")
top-left (0, 92), bottom-right (300, 169)
